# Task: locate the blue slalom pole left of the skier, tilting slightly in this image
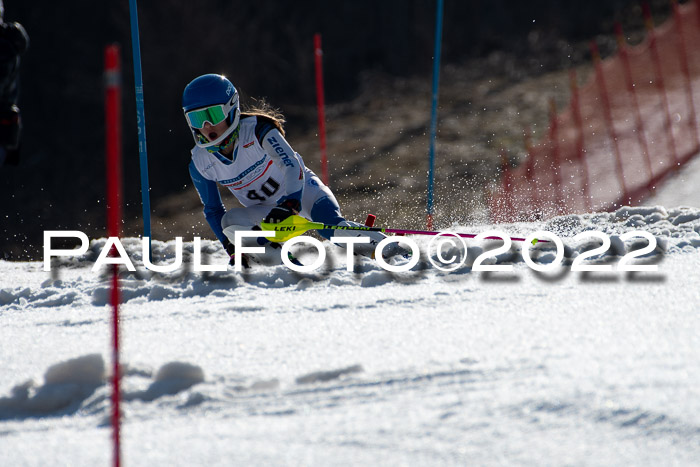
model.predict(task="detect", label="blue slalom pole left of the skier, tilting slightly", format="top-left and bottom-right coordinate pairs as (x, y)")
top-left (129, 0), bottom-right (151, 256)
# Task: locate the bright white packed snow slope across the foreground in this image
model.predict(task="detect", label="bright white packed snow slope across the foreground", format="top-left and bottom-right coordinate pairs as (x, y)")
top-left (0, 203), bottom-right (700, 466)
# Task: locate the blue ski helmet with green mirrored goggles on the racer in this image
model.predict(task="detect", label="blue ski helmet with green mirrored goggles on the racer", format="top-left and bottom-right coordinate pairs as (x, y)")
top-left (182, 74), bottom-right (241, 152)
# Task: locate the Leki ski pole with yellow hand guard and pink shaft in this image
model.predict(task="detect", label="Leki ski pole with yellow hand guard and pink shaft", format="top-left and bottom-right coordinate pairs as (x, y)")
top-left (260, 216), bottom-right (546, 242)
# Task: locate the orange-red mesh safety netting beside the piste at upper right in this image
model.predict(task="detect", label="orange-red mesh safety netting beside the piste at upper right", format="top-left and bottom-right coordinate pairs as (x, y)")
top-left (489, 0), bottom-right (700, 222)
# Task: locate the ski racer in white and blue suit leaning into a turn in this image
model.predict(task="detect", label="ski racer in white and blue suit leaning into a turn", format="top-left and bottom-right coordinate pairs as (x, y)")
top-left (182, 74), bottom-right (404, 267)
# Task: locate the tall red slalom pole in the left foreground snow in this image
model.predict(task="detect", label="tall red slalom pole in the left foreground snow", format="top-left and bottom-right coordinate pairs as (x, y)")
top-left (104, 44), bottom-right (122, 467)
